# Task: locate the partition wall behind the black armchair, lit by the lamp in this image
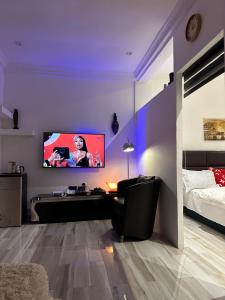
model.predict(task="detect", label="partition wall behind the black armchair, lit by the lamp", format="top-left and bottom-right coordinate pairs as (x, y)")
top-left (136, 84), bottom-right (178, 246)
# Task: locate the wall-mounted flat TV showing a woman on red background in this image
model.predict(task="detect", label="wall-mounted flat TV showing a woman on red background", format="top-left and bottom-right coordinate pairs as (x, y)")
top-left (43, 132), bottom-right (105, 168)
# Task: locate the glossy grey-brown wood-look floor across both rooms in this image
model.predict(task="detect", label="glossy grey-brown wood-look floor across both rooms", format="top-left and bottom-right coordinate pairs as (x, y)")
top-left (0, 218), bottom-right (225, 300)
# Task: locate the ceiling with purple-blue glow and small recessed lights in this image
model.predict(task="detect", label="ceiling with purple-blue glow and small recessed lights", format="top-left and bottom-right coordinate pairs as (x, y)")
top-left (0, 0), bottom-right (178, 73)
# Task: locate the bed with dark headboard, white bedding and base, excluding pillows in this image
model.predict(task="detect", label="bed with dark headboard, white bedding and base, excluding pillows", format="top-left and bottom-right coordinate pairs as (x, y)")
top-left (183, 151), bottom-right (225, 233)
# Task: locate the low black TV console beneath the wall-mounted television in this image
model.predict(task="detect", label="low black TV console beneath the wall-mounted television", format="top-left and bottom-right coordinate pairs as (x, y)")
top-left (31, 194), bottom-right (115, 223)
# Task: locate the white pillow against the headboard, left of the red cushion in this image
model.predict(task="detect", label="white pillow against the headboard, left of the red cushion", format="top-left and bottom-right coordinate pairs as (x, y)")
top-left (182, 169), bottom-right (217, 192)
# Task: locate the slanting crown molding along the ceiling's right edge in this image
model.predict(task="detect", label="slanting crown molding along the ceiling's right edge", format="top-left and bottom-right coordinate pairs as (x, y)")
top-left (134, 0), bottom-right (197, 80)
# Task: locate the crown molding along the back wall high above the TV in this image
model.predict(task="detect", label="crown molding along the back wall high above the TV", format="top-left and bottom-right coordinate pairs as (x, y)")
top-left (6, 63), bottom-right (134, 81)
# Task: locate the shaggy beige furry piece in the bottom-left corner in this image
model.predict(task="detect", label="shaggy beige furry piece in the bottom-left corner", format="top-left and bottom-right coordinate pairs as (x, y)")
top-left (0, 264), bottom-right (54, 300)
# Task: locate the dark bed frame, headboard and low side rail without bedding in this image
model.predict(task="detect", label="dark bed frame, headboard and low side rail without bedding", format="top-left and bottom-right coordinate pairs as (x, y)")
top-left (183, 151), bottom-right (225, 233)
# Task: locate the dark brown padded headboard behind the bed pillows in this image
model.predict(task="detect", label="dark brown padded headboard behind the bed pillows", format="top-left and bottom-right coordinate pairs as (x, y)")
top-left (183, 151), bottom-right (225, 170)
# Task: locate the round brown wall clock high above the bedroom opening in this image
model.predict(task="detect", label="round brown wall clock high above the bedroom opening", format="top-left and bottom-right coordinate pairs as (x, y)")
top-left (186, 14), bottom-right (202, 42)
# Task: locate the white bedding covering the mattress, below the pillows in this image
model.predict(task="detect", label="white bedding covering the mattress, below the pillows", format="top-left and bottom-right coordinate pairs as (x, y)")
top-left (184, 187), bottom-right (225, 226)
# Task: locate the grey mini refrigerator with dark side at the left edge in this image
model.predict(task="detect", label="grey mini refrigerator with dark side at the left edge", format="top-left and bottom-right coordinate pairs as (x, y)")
top-left (0, 173), bottom-right (27, 227)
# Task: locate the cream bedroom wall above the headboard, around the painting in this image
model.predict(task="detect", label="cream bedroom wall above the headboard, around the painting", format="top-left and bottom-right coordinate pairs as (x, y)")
top-left (182, 74), bottom-right (225, 150)
